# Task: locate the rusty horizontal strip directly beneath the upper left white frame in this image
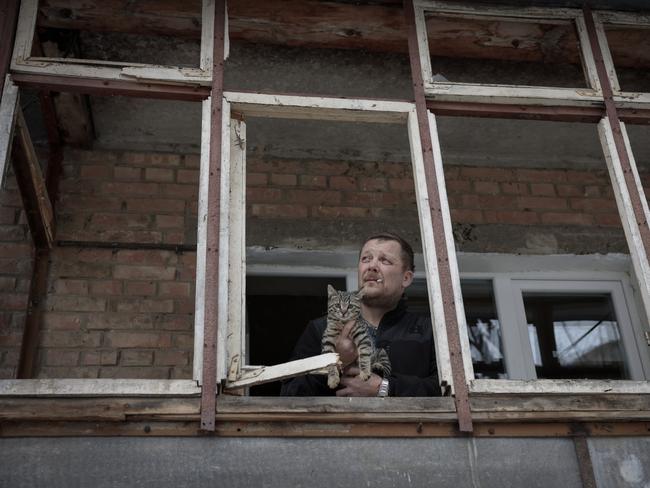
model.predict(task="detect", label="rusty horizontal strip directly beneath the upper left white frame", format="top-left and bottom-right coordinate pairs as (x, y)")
top-left (11, 73), bottom-right (210, 102)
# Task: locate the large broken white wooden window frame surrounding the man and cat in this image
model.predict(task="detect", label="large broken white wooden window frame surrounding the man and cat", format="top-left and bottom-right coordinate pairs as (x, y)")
top-left (194, 92), bottom-right (464, 389)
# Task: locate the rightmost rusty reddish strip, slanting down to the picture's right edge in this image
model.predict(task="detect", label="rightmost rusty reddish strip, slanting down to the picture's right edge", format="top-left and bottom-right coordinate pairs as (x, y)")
top-left (583, 5), bottom-right (650, 255)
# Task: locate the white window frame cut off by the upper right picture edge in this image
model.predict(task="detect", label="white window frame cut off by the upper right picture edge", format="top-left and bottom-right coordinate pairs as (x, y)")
top-left (594, 11), bottom-right (650, 109)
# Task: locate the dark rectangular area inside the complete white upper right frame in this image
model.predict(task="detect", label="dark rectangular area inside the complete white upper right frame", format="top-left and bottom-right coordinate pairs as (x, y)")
top-left (426, 14), bottom-right (587, 88)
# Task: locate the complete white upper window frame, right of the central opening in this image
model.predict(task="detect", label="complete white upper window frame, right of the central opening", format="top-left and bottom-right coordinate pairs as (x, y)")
top-left (414, 0), bottom-right (602, 106)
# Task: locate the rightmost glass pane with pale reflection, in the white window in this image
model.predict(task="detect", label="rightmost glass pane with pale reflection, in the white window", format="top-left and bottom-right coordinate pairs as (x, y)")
top-left (523, 293), bottom-right (628, 379)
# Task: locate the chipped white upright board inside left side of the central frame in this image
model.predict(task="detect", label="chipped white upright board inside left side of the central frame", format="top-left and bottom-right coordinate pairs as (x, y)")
top-left (224, 116), bottom-right (246, 381)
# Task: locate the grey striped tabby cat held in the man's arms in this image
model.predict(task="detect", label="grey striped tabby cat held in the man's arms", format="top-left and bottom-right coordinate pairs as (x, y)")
top-left (322, 285), bottom-right (391, 388)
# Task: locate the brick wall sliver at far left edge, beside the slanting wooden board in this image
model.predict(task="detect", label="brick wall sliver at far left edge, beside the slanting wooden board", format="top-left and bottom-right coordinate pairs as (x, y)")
top-left (0, 171), bottom-right (33, 378)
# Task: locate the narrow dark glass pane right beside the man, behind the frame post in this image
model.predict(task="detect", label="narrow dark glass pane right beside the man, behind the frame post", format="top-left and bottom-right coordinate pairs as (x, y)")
top-left (406, 279), bottom-right (507, 378)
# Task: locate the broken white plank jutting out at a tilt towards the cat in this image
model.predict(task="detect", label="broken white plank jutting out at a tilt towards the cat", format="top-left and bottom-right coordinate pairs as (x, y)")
top-left (226, 352), bottom-right (339, 389)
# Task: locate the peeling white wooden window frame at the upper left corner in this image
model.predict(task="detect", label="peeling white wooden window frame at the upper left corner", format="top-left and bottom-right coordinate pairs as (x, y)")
top-left (11, 0), bottom-right (223, 86)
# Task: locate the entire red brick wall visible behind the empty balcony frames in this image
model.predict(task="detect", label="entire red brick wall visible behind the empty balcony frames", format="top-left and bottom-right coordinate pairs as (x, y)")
top-left (0, 147), bottom-right (632, 378)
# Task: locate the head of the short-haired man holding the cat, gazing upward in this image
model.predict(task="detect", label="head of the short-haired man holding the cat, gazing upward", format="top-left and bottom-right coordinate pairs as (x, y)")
top-left (359, 239), bottom-right (413, 307)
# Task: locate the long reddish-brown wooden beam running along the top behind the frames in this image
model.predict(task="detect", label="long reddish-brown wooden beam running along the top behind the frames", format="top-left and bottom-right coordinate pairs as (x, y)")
top-left (31, 0), bottom-right (650, 67)
